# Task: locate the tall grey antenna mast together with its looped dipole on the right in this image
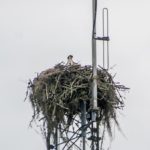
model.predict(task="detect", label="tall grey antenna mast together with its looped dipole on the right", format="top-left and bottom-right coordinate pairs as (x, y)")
top-left (91, 0), bottom-right (109, 150)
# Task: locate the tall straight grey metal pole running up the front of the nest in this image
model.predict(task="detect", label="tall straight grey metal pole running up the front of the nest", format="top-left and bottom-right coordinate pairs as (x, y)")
top-left (91, 0), bottom-right (97, 121)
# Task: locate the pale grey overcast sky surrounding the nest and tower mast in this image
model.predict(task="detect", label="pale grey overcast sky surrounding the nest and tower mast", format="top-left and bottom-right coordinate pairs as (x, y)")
top-left (0, 0), bottom-right (150, 150)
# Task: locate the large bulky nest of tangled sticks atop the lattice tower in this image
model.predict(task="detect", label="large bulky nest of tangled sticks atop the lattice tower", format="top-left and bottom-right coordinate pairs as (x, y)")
top-left (25, 63), bottom-right (127, 146)
